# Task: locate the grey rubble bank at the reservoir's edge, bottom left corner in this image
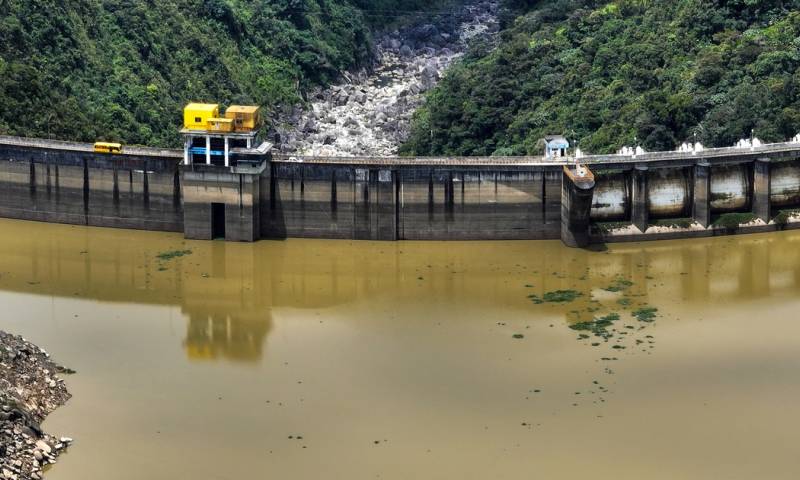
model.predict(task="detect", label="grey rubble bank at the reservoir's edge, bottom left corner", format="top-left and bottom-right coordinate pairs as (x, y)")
top-left (0, 331), bottom-right (72, 480)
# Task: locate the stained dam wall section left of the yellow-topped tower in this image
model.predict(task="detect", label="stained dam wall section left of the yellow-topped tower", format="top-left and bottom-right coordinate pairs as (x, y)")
top-left (0, 142), bottom-right (183, 232)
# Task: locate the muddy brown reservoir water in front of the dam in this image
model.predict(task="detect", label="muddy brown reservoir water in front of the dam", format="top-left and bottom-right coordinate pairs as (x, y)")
top-left (0, 220), bottom-right (800, 480)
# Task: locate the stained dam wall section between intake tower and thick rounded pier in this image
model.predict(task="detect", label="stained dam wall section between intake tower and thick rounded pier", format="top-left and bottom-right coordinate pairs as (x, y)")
top-left (261, 161), bottom-right (561, 240)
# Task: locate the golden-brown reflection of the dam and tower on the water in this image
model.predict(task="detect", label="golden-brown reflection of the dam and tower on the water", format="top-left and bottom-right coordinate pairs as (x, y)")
top-left (0, 221), bottom-right (800, 361)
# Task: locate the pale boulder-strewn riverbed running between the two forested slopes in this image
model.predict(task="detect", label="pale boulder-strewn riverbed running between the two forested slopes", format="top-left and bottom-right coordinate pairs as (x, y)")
top-left (271, 0), bottom-right (499, 156)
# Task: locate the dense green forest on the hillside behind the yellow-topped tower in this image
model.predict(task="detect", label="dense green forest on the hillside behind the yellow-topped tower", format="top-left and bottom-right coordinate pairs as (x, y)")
top-left (0, 0), bottom-right (450, 145)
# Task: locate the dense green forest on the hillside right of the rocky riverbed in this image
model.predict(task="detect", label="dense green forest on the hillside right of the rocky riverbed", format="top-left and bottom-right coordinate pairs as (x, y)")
top-left (403, 0), bottom-right (800, 155)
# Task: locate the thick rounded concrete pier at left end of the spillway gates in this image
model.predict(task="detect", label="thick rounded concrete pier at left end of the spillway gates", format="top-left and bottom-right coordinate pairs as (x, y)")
top-left (561, 166), bottom-right (595, 248)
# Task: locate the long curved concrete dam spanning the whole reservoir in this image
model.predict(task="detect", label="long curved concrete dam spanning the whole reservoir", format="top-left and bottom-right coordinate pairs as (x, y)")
top-left (0, 137), bottom-right (800, 246)
